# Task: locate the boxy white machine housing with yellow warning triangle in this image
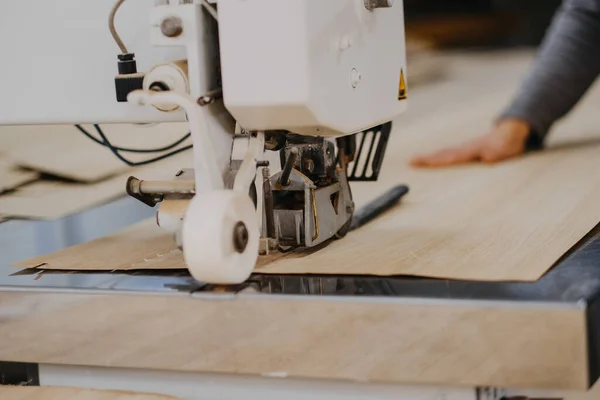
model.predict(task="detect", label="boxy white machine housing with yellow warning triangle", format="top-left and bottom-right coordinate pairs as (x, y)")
top-left (218, 0), bottom-right (406, 136)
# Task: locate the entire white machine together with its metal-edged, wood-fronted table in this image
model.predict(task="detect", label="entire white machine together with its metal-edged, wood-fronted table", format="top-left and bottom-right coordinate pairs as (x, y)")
top-left (0, 0), bottom-right (600, 400)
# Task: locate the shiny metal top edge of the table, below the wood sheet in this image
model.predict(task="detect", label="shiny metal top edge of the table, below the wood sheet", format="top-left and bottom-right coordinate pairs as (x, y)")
top-left (0, 222), bottom-right (600, 303)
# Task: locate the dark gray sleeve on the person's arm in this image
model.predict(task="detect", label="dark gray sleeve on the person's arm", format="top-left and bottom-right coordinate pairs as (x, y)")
top-left (500, 0), bottom-right (600, 143)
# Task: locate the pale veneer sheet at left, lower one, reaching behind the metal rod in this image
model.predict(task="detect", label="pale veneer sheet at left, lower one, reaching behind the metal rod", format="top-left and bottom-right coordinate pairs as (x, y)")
top-left (0, 150), bottom-right (193, 219)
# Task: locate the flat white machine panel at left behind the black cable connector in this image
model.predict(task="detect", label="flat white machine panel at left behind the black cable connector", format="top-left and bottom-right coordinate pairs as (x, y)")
top-left (0, 0), bottom-right (185, 124)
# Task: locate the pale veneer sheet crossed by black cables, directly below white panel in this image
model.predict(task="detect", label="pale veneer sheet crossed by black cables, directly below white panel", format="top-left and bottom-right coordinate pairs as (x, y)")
top-left (0, 123), bottom-right (191, 182)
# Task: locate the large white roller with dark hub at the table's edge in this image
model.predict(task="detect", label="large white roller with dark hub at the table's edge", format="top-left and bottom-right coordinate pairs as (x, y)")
top-left (182, 190), bottom-right (260, 284)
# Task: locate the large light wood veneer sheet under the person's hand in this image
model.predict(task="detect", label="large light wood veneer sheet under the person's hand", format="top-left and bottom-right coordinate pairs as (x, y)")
top-left (11, 50), bottom-right (600, 281)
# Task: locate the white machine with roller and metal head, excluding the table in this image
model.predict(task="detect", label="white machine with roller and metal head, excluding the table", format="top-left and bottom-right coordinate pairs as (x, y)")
top-left (0, 0), bottom-right (407, 284)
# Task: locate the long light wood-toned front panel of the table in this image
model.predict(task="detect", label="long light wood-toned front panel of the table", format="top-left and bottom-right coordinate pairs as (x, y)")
top-left (0, 292), bottom-right (588, 390)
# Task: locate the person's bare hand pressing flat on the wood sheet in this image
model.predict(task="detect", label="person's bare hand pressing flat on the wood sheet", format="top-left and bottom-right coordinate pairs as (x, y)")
top-left (411, 119), bottom-right (530, 167)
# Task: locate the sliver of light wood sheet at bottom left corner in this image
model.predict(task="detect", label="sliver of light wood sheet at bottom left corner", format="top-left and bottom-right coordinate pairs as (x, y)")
top-left (0, 386), bottom-right (176, 400)
